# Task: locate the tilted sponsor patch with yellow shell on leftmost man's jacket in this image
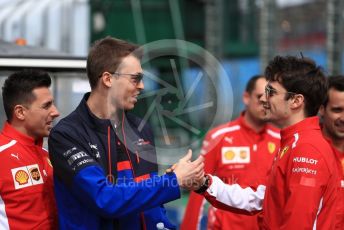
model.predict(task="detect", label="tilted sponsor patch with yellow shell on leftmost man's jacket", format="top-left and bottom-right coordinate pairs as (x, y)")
top-left (11, 164), bottom-right (43, 189)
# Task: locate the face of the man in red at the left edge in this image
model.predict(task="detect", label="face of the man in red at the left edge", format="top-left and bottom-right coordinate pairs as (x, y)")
top-left (21, 87), bottom-right (60, 140)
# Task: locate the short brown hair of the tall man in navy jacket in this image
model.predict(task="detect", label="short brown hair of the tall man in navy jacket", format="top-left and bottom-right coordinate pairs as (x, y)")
top-left (86, 37), bottom-right (142, 89)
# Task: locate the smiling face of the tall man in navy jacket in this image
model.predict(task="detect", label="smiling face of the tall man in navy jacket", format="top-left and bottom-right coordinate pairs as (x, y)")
top-left (109, 55), bottom-right (144, 110)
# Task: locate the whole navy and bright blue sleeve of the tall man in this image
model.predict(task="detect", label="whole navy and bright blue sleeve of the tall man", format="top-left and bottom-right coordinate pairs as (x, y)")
top-left (48, 126), bottom-right (180, 218)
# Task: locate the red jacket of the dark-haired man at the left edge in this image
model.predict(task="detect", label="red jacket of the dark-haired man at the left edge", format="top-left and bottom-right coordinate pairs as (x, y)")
top-left (0, 123), bottom-right (57, 230)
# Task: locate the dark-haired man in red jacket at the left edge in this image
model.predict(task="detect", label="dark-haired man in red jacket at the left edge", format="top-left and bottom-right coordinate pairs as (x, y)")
top-left (0, 70), bottom-right (60, 230)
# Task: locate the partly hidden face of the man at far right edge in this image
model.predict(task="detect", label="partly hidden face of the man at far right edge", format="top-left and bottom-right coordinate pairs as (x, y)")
top-left (320, 88), bottom-right (344, 140)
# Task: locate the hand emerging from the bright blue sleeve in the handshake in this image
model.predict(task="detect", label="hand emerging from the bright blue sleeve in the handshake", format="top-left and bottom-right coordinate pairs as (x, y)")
top-left (172, 150), bottom-right (204, 190)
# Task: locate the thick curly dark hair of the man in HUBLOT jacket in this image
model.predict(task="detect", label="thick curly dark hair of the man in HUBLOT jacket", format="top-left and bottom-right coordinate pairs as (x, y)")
top-left (265, 56), bottom-right (327, 117)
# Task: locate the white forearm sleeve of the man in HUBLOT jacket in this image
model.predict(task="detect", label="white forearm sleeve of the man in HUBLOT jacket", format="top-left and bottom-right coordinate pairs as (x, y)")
top-left (207, 176), bottom-right (265, 212)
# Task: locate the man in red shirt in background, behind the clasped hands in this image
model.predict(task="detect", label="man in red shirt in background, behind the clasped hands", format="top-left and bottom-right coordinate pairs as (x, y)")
top-left (181, 75), bottom-right (280, 230)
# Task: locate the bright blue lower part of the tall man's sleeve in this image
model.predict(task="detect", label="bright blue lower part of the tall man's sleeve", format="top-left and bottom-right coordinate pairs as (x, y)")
top-left (73, 166), bottom-right (180, 218)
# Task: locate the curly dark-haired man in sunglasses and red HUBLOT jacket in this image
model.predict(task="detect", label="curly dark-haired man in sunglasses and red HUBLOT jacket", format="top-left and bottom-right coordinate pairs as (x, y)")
top-left (191, 56), bottom-right (339, 230)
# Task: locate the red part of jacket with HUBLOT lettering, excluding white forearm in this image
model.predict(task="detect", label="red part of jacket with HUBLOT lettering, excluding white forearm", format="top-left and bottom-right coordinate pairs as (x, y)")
top-left (261, 117), bottom-right (338, 230)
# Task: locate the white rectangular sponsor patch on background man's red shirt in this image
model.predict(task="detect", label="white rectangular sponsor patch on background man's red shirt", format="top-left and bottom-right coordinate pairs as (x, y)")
top-left (221, 146), bottom-right (250, 164)
